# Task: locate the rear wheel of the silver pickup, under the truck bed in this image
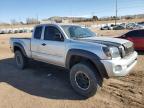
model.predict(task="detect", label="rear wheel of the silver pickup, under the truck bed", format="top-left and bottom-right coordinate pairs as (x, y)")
top-left (15, 50), bottom-right (28, 69)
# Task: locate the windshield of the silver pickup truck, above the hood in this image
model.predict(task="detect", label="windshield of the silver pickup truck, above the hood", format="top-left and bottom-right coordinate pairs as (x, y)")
top-left (61, 25), bottom-right (96, 38)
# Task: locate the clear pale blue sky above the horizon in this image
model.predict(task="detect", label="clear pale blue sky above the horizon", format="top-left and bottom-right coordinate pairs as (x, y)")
top-left (0, 0), bottom-right (144, 22)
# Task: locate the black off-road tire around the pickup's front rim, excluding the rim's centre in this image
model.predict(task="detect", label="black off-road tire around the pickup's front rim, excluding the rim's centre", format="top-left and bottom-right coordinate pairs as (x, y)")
top-left (70, 63), bottom-right (101, 97)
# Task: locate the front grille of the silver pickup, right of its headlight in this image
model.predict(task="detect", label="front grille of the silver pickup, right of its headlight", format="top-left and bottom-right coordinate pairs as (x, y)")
top-left (123, 42), bottom-right (134, 56)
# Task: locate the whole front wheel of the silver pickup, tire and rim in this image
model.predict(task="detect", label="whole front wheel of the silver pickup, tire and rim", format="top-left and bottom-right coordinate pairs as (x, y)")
top-left (70, 63), bottom-right (99, 97)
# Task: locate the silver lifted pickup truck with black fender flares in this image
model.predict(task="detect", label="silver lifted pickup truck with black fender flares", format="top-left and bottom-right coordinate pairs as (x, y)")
top-left (10, 24), bottom-right (137, 97)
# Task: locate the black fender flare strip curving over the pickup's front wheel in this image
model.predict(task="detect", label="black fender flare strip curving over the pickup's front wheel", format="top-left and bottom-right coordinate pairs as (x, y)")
top-left (65, 49), bottom-right (108, 78)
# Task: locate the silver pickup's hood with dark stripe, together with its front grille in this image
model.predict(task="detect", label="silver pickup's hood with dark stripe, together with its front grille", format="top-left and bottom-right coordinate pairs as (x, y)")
top-left (73, 37), bottom-right (134, 57)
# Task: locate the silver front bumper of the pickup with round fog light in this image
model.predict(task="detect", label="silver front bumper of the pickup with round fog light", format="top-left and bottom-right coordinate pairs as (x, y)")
top-left (101, 52), bottom-right (138, 77)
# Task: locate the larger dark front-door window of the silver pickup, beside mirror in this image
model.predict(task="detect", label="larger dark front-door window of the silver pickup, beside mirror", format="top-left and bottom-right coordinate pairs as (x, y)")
top-left (44, 26), bottom-right (63, 41)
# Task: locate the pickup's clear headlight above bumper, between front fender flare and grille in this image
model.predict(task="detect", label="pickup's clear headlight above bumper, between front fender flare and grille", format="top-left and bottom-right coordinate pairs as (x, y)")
top-left (103, 47), bottom-right (120, 59)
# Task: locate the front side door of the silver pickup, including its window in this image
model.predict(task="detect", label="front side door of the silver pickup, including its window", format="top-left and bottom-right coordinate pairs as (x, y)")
top-left (40, 26), bottom-right (65, 66)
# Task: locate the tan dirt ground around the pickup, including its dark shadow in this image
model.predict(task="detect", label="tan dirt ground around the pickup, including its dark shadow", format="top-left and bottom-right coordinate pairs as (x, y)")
top-left (0, 31), bottom-right (144, 108)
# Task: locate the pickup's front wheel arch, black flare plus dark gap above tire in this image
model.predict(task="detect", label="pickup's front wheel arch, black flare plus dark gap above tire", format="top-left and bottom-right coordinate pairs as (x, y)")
top-left (65, 49), bottom-right (108, 78)
